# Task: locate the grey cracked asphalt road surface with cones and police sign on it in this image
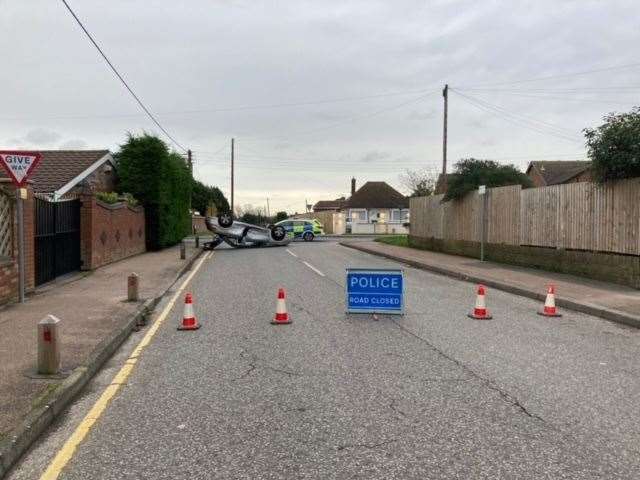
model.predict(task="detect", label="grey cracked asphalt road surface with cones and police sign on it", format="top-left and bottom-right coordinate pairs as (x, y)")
top-left (9, 242), bottom-right (640, 480)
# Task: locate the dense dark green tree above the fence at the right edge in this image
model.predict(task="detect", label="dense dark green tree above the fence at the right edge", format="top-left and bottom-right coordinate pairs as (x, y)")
top-left (584, 107), bottom-right (640, 182)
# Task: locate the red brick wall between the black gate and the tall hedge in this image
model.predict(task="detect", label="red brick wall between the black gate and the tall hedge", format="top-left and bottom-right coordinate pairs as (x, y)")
top-left (80, 194), bottom-right (146, 270)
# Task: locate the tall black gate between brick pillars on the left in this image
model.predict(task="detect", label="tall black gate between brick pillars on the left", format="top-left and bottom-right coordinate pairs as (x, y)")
top-left (35, 198), bottom-right (80, 285)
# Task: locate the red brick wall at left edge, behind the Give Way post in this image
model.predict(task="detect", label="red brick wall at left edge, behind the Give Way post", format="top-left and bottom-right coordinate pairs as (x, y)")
top-left (0, 182), bottom-right (35, 305)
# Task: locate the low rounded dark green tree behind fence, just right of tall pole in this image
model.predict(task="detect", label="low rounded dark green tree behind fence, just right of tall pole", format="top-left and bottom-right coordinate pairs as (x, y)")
top-left (443, 158), bottom-right (533, 202)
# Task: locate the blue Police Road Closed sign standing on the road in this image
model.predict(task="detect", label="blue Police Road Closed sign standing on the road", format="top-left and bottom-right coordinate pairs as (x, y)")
top-left (346, 268), bottom-right (404, 315)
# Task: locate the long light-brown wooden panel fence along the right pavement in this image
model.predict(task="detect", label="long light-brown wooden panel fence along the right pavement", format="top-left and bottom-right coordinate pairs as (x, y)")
top-left (411, 178), bottom-right (640, 255)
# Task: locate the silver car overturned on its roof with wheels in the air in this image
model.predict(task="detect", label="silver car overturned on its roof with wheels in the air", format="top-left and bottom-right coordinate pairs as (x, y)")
top-left (205, 212), bottom-right (292, 250)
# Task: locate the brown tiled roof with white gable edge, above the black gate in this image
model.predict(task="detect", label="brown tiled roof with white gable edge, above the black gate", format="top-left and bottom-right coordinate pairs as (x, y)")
top-left (0, 150), bottom-right (113, 194)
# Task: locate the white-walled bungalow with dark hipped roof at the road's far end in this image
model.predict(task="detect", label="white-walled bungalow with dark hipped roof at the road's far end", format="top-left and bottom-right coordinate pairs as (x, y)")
top-left (342, 179), bottom-right (409, 233)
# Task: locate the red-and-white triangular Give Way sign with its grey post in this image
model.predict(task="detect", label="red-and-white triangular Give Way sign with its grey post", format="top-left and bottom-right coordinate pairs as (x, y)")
top-left (0, 150), bottom-right (41, 303)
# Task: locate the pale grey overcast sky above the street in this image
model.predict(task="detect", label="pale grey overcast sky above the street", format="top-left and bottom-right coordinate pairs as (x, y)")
top-left (0, 0), bottom-right (640, 213)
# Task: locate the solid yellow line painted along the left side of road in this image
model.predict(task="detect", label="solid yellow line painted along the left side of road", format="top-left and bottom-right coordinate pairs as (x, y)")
top-left (40, 252), bottom-right (213, 480)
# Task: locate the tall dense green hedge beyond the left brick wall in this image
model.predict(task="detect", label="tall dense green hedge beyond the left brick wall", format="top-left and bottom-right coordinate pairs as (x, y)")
top-left (116, 133), bottom-right (192, 250)
